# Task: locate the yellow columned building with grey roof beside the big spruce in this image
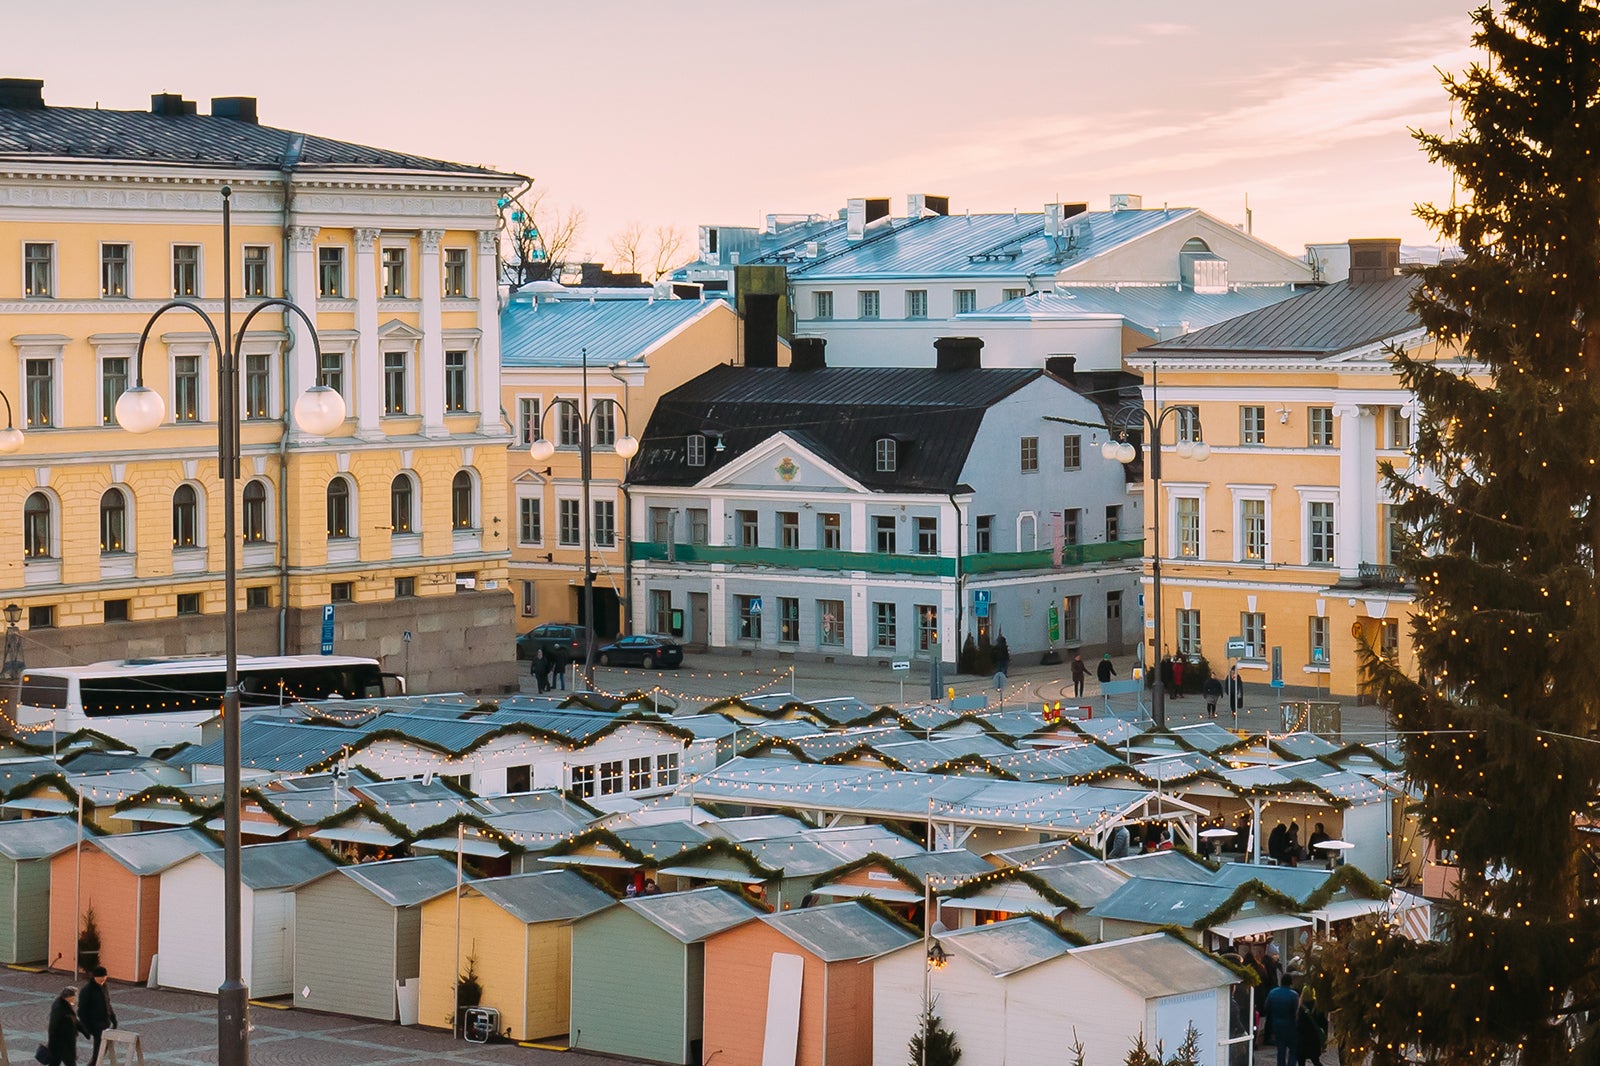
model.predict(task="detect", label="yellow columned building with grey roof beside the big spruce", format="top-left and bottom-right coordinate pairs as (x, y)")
top-left (1128, 240), bottom-right (1434, 706)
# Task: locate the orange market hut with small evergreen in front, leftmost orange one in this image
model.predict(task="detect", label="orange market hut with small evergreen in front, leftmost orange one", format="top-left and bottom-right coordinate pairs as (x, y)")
top-left (50, 829), bottom-right (218, 988)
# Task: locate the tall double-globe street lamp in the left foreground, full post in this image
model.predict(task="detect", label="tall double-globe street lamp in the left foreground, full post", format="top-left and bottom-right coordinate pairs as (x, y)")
top-left (117, 186), bottom-right (344, 1066)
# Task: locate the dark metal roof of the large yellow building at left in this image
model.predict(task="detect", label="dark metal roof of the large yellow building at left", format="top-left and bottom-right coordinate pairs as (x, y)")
top-left (0, 107), bottom-right (501, 178)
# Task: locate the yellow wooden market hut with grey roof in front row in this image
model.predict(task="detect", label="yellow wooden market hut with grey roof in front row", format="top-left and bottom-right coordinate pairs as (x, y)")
top-left (419, 869), bottom-right (614, 1040)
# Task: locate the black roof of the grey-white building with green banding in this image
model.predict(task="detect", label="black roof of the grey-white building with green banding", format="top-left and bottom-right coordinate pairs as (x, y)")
top-left (629, 367), bottom-right (1043, 493)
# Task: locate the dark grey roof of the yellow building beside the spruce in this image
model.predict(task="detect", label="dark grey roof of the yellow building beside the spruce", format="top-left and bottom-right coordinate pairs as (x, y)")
top-left (1139, 274), bottom-right (1422, 355)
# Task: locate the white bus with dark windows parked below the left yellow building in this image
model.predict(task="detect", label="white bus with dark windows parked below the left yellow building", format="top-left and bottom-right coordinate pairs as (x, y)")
top-left (16, 655), bottom-right (405, 752)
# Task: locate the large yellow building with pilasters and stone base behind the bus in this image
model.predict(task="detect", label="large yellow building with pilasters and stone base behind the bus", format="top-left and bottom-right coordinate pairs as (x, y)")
top-left (0, 78), bottom-right (523, 691)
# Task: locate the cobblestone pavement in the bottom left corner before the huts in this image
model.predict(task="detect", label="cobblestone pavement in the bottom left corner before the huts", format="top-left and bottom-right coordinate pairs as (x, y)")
top-left (0, 967), bottom-right (624, 1066)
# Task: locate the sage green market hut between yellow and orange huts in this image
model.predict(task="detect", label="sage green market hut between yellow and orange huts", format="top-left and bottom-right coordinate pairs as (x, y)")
top-left (571, 887), bottom-right (763, 1066)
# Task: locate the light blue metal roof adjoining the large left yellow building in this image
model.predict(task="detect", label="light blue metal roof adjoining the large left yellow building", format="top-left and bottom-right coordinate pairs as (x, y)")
top-left (501, 293), bottom-right (726, 368)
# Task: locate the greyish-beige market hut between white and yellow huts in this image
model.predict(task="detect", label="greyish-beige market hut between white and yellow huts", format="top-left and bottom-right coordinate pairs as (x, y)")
top-left (294, 855), bottom-right (456, 1021)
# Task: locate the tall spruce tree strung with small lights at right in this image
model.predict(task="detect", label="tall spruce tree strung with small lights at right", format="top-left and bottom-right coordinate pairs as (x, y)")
top-left (1326, 0), bottom-right (1600, 1066)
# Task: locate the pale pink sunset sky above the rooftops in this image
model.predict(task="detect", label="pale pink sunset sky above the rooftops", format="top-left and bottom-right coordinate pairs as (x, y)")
top-left (18, 0), bottom-right (1472, 258)
